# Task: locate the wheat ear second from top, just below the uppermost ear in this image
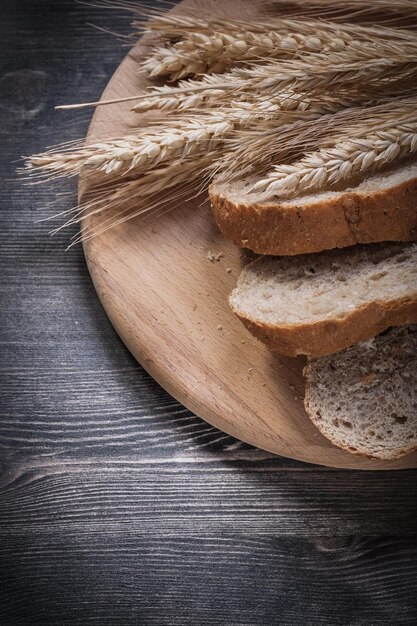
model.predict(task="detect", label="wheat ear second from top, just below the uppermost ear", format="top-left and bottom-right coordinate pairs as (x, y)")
top-left (133, 52), bottom-right (417, 112)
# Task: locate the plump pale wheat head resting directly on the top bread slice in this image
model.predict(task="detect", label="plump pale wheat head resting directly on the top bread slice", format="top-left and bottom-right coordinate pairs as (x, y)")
top-left (250, 113), bottom-right (417, 198)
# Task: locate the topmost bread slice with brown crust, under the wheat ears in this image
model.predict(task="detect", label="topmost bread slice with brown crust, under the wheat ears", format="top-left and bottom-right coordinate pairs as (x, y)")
top-left (209, 160), bottom-right (417, 256)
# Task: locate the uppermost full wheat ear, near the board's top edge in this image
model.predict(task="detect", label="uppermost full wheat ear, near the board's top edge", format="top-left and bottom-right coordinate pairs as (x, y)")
top-left (138, 18), bottom-right (417, 81)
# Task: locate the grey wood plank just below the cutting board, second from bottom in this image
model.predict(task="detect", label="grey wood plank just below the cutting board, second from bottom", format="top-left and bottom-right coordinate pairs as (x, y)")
top-left (0, 464), bottom-right (417, 536)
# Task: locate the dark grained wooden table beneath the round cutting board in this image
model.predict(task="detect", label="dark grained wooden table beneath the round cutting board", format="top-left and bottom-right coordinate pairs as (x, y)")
top-left (0, 0), bottom-right (417, 626)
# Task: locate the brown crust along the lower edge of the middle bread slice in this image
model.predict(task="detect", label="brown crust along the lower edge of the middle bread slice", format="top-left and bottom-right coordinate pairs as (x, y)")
top-left (232, 298), bottom-right (417, 357)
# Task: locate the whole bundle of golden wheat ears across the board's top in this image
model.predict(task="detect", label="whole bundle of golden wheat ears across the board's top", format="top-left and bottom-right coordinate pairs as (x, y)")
top-left (25, 0), bottom-right (417, 240)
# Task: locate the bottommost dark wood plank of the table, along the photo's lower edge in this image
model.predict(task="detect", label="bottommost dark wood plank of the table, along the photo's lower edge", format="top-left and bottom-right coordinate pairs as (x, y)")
top-left (0, 525), bottom-right (417, 626)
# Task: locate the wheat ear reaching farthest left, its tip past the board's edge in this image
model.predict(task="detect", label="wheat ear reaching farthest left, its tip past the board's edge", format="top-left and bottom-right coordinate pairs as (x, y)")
top-left (26, 93), bottom-right (316, 178)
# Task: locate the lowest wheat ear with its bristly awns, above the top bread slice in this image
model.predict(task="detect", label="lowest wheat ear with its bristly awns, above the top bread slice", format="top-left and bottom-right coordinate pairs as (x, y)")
top-left (216, 97), bottom-right (417, 188)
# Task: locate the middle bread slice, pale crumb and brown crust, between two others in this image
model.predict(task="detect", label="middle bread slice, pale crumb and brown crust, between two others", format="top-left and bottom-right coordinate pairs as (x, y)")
top-left (229, 243), bottom-right (417, 356)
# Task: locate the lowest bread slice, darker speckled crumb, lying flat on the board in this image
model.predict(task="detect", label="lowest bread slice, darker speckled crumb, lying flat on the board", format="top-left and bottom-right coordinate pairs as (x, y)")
top-left (304, 325), bottom-right (417, 459)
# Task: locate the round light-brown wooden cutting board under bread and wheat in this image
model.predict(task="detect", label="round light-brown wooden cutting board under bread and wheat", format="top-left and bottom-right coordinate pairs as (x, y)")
top-left (80, 0), bottom-right (417, 470)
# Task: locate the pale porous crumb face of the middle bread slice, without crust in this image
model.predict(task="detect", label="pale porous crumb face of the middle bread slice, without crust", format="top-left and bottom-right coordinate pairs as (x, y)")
top-left (230, 243), bottom-right (417, 326)
